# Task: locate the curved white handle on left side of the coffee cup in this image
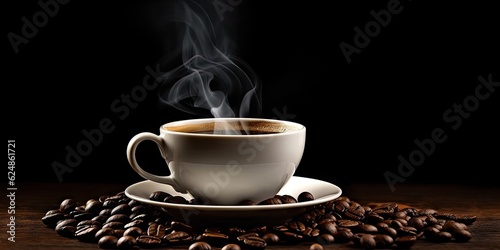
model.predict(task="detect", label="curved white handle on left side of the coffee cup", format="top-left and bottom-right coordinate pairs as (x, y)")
top-left (127, 132), bottom-right (187, 193)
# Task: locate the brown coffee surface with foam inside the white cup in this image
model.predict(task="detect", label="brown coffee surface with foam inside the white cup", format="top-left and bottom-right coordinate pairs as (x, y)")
top-left (163, 121), bottom-right (300, 134)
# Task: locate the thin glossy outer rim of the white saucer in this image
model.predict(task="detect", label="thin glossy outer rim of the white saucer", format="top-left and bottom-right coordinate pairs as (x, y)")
top-left (125, 176), bottom-right (342, 212)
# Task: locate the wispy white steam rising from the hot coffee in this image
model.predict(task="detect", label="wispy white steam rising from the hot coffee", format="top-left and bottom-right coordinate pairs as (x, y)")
top-left (159, 1), bottom-right (261, 117)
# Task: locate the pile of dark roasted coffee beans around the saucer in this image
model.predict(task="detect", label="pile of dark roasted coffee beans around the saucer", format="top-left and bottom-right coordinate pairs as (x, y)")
top-left (41, 191), bottom-right (476, 250)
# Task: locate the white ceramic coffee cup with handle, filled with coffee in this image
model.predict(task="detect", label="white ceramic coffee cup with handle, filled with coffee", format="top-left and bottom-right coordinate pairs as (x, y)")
top-left (127, 118), bottom-right (306, 205)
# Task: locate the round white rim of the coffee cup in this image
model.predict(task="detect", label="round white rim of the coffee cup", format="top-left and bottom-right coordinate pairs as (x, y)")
top-left (160, 117), bottom-right (306, 138)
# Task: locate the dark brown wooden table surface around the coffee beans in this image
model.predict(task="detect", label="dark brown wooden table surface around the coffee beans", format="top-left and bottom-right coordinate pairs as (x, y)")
top-left (0, 183), bottom-right (500, 250)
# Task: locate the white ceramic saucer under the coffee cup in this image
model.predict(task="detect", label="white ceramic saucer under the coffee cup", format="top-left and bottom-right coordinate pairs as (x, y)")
top-left (125, 176), bottom-right (342, 225)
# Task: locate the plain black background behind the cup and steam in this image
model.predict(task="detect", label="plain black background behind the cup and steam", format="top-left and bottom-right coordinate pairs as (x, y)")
top-left (2, 0), bottom-right (500, 191)
